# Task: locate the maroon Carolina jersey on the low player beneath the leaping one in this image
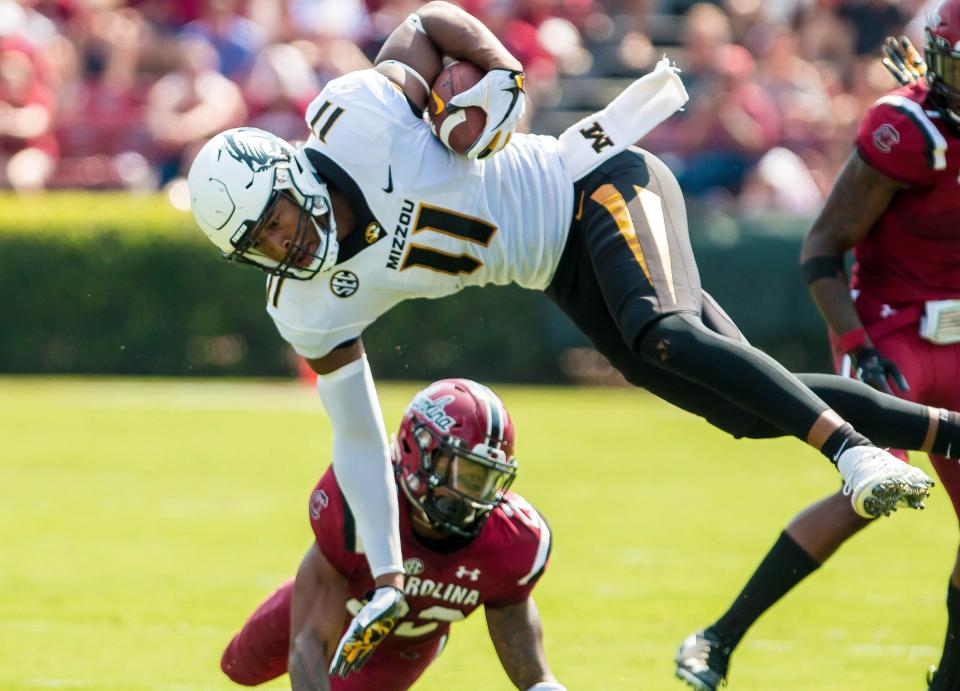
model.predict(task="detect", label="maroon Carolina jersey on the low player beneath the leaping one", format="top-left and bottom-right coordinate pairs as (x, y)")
top-left (310, 467), bottom-right (551, 650)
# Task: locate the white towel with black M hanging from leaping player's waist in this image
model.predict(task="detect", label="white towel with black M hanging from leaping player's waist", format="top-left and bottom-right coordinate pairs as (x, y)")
top-left (560, 57), bottom-right (690, 181)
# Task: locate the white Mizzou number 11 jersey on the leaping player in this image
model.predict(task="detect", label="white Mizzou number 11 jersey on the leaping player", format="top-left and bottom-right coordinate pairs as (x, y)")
top-left (267, 69), bottom-right (573, 358)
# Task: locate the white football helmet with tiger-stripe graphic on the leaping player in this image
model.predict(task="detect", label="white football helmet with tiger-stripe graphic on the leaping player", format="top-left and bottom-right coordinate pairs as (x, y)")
top-left (187, 127), bottom-right (339, 280)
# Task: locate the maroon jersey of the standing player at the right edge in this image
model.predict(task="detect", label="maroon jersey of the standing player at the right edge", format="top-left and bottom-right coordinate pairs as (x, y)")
top-left (852, 82), bottom-right (960, 304)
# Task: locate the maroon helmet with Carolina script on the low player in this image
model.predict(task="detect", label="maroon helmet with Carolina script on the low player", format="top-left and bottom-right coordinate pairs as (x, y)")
top-left (393, 379), bottom-right (517, 537)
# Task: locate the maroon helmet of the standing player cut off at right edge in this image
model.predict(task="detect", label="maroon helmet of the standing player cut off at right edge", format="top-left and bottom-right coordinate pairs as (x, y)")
top-left (924, 0), bottom-right (960, 126)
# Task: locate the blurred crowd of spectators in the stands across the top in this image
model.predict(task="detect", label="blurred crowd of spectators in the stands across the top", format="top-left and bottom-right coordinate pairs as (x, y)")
top-left (0, 0), bottom-right (944, 213)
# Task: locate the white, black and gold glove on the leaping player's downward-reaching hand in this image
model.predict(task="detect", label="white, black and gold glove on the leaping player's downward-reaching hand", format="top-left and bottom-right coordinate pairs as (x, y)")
top-left (330, 585), bottom-right (404, 677)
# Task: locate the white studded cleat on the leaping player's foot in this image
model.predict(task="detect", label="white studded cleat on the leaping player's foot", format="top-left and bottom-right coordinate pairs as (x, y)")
top-left (837, 446), bottom-right (934, 518)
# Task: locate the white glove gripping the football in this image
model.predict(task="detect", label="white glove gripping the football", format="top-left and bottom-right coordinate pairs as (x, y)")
top-left (447, 68), bottom-right (526, 158)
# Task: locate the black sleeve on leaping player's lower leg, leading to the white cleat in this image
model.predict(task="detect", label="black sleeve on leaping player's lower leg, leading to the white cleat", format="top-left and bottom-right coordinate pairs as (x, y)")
top-left (634, 313), bottom-right (828, 441)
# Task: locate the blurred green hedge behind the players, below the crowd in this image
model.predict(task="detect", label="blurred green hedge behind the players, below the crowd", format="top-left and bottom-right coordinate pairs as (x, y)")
top-left (0, 194), bottom-right (825, 382)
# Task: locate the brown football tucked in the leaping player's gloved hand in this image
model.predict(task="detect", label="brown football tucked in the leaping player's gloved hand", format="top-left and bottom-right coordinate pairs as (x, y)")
top-left (427, 61), bottom-right (487, 154)
